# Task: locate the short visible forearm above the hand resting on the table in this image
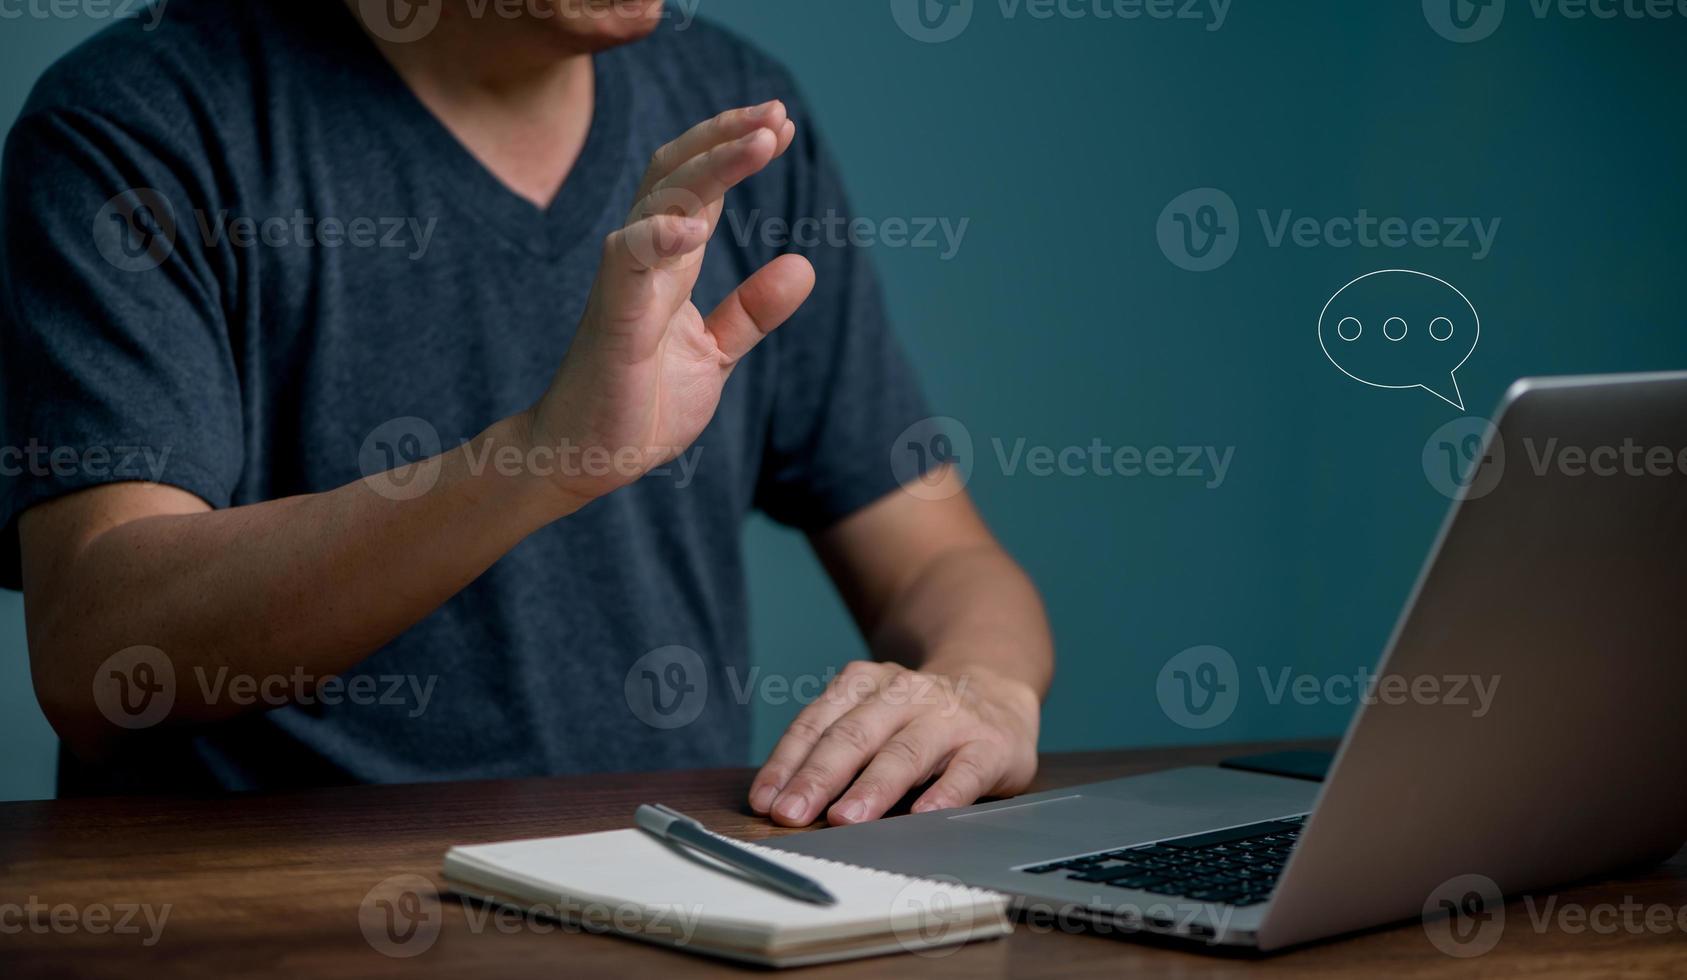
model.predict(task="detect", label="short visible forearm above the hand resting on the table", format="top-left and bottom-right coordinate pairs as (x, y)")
top-left (870, 543), bottom-right (1054, 698)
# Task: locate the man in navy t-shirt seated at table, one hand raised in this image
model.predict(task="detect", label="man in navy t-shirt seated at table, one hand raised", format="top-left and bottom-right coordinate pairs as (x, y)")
top-left (0, 0), bottom-right (1053, 825)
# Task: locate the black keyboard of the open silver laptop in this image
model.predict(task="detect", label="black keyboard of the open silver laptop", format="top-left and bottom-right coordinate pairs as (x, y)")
top-left (1021, 813), bottom-right (1306, 907)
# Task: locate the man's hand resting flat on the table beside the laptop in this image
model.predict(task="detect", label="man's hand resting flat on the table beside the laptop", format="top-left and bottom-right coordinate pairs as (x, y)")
top-left (749, 661), bottom-right (1039, 827)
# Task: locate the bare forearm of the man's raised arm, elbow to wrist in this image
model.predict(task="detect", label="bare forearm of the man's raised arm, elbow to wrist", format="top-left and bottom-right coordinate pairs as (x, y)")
top-left (24, 408), bottom-right (570, 754)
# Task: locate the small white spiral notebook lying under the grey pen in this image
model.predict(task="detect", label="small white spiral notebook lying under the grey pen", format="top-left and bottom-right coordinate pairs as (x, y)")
top-left (444, 828), bottom-right (1012, 967)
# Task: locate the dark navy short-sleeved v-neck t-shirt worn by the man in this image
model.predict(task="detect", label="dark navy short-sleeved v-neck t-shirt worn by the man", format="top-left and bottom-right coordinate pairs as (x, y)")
top-left (0, 0), bottom-right (924, 791)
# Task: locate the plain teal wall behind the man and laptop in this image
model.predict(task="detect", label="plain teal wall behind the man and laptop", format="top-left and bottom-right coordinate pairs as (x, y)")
top-left (0, 0), bottom-right (1687, 798)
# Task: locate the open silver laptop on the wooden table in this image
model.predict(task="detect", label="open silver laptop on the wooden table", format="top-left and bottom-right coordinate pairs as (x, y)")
top-left (773, 373), bottom-right (1687, 950)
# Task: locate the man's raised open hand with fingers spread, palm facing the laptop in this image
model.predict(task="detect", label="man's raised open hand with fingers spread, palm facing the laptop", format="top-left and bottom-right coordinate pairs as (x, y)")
top-left (521, 101), bottom-right (815, 509)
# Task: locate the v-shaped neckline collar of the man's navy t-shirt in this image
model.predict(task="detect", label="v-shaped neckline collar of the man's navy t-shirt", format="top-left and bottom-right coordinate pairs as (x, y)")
top-left (329, 0), bottom-right (633, 258)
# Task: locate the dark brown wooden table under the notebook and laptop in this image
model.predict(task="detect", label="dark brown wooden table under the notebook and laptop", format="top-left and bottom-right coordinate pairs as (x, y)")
top-left (0, 744), bottom-right (1687, 980)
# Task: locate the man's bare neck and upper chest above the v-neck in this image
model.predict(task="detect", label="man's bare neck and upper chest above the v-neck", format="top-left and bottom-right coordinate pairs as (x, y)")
top-left (353, 0), bottom-right (594, 207)
